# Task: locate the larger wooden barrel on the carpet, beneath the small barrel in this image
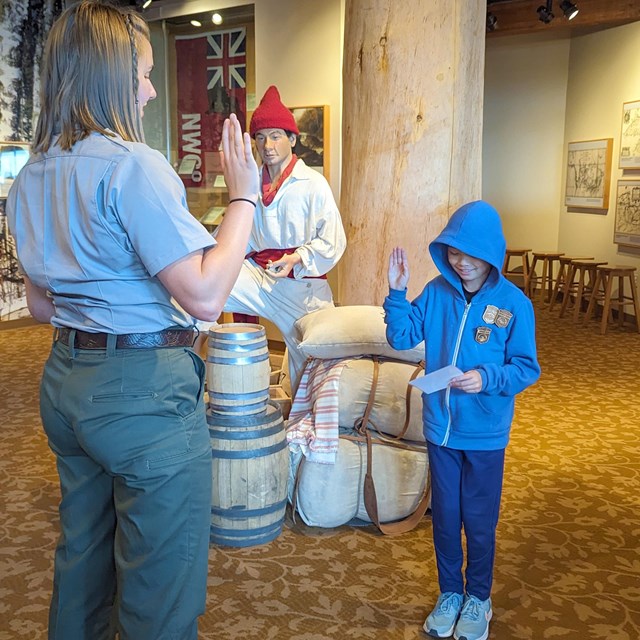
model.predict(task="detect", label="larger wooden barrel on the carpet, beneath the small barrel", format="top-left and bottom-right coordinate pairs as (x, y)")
top-left (207, 402), bottom-right (289, 547)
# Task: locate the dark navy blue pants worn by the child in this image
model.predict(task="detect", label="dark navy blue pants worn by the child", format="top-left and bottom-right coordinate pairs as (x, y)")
top-left (427, 442), bottom-right (505, 600)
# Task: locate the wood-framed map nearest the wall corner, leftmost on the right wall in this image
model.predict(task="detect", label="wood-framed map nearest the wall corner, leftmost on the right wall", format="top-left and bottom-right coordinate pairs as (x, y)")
top-left (564, 138), bottom-right (613, 210)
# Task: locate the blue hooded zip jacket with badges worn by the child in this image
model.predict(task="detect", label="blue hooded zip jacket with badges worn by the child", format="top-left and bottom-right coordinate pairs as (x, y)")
top-left (383, 200), bottom-right (540, 450)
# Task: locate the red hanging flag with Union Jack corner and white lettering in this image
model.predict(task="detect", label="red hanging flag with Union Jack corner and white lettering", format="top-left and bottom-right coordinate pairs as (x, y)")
top-left (176, 27), bottom-right (247, 187)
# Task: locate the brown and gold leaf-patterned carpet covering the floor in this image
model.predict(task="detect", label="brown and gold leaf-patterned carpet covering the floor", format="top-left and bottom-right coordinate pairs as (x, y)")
top-left (0, 310), bottom-right (640, 640)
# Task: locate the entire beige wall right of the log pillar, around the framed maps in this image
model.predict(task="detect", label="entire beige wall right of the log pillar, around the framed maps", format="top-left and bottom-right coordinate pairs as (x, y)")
top-left (483, 22), bottom-right (640, 267)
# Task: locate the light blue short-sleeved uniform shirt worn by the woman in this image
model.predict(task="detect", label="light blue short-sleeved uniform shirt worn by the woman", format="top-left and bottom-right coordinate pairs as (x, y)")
top-left (7, 133), bottom-right (215, 334)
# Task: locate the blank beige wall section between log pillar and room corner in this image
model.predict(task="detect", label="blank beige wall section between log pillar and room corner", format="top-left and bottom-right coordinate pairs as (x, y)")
top-left (482, 35), bottom-right (571, 251)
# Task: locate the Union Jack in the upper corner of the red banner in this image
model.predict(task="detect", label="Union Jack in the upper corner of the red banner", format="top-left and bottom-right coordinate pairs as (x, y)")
top-left (207, 27), bottom-right (247, 90)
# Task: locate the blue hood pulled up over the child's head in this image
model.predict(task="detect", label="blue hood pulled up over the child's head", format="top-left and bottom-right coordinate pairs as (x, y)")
top-left (429, 200), bottom-right (507, 290)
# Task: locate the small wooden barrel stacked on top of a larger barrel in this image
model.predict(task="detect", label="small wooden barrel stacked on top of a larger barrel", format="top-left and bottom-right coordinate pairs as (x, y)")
top-left (207, 322), bottom-right (271, 415)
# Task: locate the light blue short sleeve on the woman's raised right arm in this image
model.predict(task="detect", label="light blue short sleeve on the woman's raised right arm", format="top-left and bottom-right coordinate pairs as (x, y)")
top-left (106, 147), bottom-right (216, 276)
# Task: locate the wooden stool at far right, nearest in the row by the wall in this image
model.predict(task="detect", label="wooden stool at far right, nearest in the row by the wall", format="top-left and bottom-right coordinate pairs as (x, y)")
top-left (585, 265), bottom-right (640, 334)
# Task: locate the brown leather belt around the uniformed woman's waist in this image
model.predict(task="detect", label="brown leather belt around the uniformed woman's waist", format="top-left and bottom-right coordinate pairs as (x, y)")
top-left (54, 327), bottom-right (197, 349)
